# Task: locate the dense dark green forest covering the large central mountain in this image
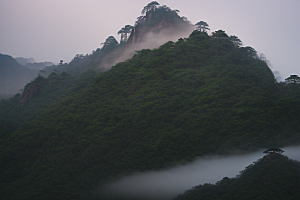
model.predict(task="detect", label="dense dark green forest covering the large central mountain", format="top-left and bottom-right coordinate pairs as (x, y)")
top-left (0, 1), bottom-right (300, 200)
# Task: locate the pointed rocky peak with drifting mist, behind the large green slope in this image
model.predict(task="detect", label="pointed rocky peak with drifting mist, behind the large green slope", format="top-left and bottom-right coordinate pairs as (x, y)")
top-left (40, 3), bottom-right (194, 76)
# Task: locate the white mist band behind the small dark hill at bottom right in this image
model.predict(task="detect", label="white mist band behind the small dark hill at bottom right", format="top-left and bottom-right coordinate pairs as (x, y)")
top-left (106, 146), bottom-right (300, 199)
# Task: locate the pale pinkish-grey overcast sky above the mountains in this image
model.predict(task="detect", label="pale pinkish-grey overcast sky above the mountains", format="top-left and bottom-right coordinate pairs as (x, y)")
top-left (0, 0), bottom-right (300, 78)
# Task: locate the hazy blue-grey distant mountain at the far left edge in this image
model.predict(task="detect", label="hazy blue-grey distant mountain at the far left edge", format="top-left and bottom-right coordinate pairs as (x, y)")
top-left (0, 54), bottom-right (38, 99)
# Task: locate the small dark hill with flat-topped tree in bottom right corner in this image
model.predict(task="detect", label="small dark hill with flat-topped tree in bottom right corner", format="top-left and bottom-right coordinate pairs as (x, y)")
top-left (174, 153), bottom-right (300, 200)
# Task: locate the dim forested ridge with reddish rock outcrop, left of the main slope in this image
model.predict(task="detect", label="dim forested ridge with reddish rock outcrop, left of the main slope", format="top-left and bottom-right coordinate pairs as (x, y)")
top-left (0, 70), bottom-right (96, 139)
